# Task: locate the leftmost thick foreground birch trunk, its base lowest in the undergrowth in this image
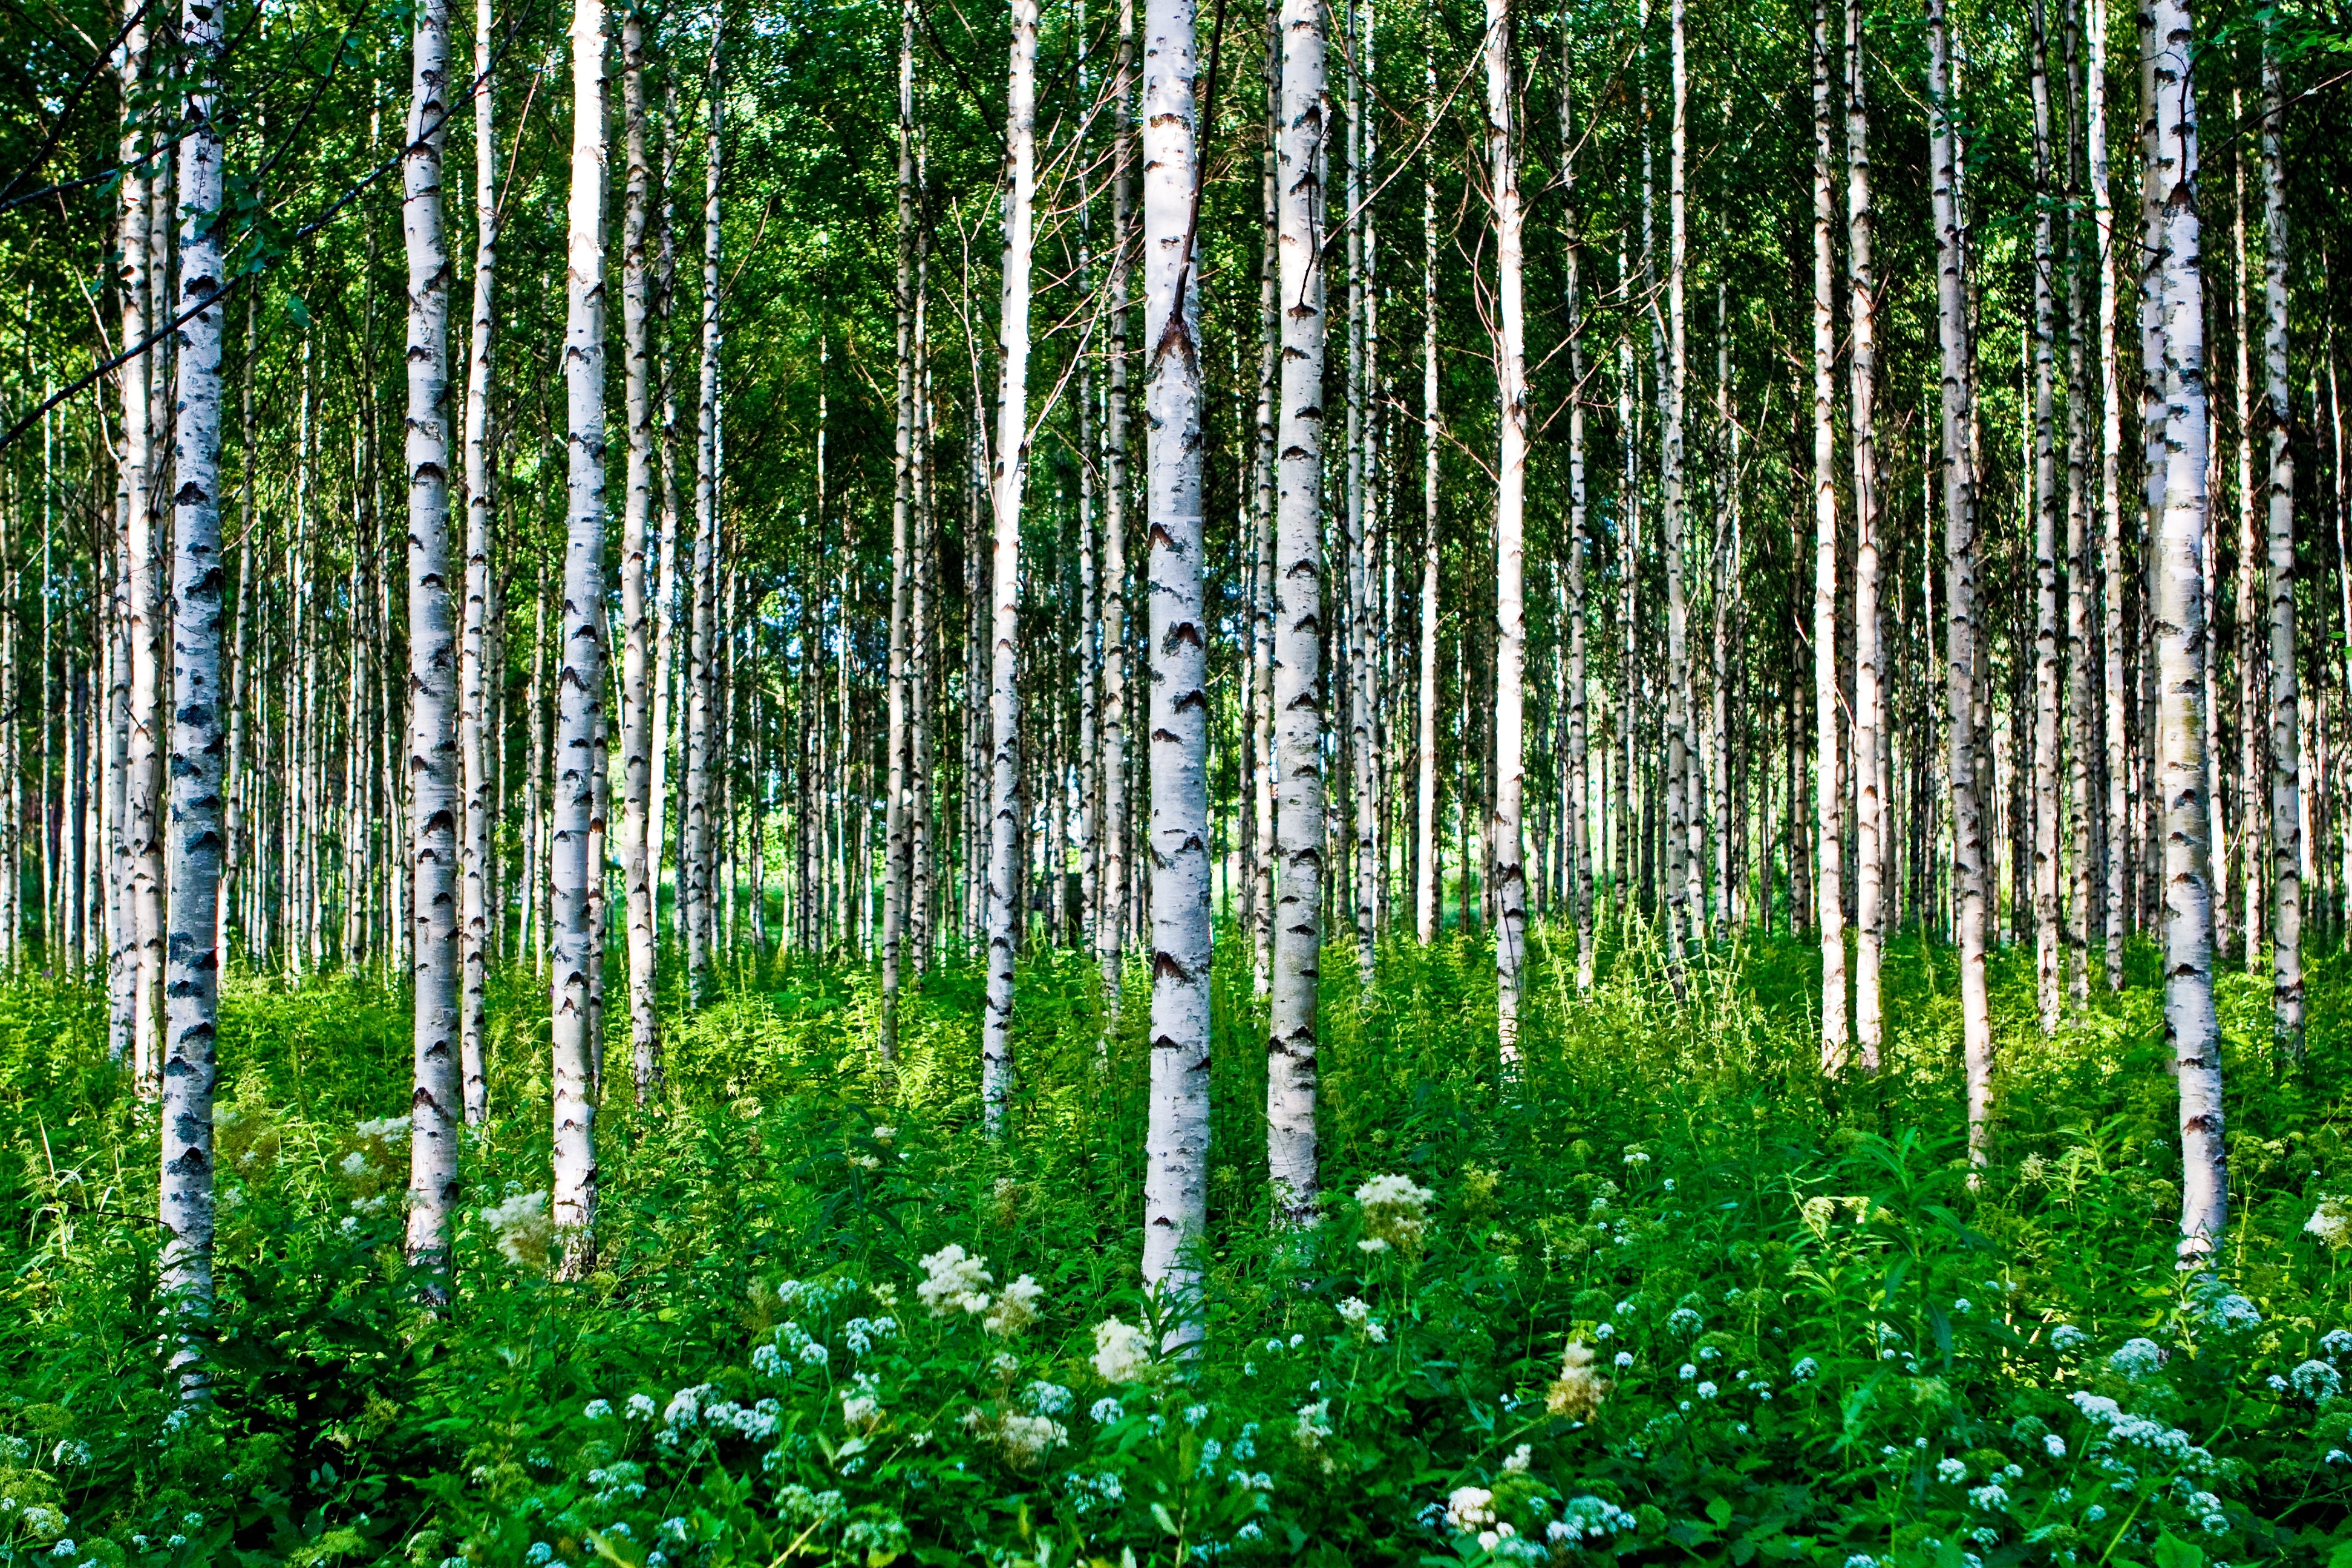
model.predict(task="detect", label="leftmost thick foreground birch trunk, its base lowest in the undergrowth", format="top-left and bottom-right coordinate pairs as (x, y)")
top-left (160, 0), bottom-right (228, 1396)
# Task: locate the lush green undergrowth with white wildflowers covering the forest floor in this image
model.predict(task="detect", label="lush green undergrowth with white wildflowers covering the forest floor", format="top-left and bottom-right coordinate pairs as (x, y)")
top-left (0, 933), bottom-right (2352, 1568)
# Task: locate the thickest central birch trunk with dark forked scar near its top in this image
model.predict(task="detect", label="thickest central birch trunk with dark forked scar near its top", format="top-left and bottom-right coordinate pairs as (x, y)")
top-left (1138, 0), bottom-right (1209, 1342)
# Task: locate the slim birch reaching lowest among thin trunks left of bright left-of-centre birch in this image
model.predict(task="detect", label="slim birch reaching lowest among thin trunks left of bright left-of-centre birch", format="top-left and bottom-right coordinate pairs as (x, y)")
top-left (880, 0), bottom-right (915, 1060)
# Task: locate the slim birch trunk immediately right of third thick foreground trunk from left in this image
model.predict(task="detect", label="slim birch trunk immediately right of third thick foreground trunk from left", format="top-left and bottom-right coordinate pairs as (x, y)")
top-left (621, 10), bottom-right (661, 1096)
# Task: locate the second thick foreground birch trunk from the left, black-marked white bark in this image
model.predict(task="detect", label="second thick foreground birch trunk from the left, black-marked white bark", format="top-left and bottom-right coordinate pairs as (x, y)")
top-left (402, 0), bottom-right (466, 1300)
